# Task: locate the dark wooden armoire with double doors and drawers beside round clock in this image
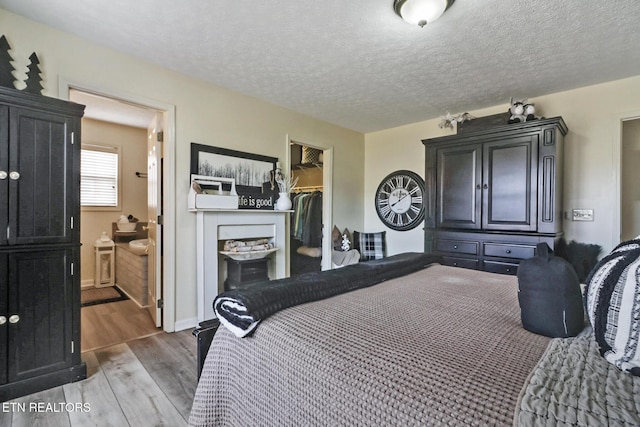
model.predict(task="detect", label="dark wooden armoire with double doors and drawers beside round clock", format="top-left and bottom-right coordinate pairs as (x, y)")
top-left (422, 117), bottom-right (567, 274)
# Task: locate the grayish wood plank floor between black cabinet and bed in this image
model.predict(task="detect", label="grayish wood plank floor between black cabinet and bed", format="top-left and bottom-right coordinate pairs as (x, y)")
top-left (0, 330), bottom-right (197, 427)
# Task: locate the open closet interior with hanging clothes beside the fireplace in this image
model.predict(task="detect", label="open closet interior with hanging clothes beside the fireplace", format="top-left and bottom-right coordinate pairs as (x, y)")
top-left (289, 141), bottom-right (327, 277)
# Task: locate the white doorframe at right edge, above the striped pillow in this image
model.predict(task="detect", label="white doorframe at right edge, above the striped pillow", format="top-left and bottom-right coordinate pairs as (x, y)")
top-left (611, 110), bottom-right (640, 247)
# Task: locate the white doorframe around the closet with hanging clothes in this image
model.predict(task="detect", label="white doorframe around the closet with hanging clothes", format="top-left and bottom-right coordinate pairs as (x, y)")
top-left (284, 134), bottom-right (333, 271)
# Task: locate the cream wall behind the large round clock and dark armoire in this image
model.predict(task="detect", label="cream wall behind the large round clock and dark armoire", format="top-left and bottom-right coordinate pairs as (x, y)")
top-left (364, 76), bottom-right (640, 254)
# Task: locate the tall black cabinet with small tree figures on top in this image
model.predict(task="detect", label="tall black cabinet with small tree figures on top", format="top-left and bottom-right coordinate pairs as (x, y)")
top-left (0, 88), bottom-right (86, 401)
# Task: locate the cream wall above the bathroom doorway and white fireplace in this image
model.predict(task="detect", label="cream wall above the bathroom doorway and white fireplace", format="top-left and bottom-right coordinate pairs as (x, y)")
top-left (0, 9), bottom-right (364, 330)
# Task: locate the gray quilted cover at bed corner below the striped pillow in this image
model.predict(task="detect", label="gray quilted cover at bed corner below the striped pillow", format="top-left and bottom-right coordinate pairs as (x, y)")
top-left (515, 327), bottom-right (640, 427)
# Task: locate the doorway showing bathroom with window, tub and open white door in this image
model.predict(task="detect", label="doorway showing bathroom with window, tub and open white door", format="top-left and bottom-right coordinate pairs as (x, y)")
top-left (69, 88), bottom-right (168, 351)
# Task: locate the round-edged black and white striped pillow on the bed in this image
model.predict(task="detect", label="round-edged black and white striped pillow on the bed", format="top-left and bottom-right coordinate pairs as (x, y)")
top-left (586, 236), bottom-right (640, 376)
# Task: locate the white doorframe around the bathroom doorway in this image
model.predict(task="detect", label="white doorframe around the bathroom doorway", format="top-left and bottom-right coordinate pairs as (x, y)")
top-left (58, 77), bottom-right (176, 332)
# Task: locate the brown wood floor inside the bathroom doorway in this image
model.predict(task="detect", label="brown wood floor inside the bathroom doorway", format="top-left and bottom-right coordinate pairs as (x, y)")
top-left (80, 299), bottom-right (162, 352)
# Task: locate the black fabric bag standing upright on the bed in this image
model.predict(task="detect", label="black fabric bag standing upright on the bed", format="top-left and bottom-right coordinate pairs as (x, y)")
top-left (518, 243), bottom-right (584, 338)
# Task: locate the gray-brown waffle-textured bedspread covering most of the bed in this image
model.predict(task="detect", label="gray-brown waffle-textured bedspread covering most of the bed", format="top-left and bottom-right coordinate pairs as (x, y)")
top-left (189, 265), bottom-right (549, 427)
